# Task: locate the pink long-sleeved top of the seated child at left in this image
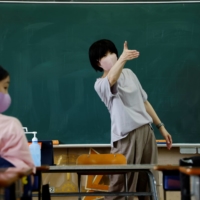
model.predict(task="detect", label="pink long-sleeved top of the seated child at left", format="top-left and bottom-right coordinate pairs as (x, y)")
top-left (0, 114), bottom-right (34, 168)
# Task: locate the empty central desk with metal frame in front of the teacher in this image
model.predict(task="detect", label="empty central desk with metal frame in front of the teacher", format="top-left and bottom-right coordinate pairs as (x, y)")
top-left (38, 164), bottom-right (158, 200)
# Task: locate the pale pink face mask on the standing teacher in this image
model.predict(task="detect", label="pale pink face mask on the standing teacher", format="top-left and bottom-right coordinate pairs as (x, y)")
top-left (100, 53), bottom-right (117, 71)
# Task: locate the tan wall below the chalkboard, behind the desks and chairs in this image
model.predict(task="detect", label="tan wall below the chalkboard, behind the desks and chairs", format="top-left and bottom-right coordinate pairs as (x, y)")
top-left (35, 147), bottom-right (198, 200)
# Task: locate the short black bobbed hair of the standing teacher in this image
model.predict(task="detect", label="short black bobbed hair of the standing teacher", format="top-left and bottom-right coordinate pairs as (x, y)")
top-left (89, 39), bottom-right (118, 72)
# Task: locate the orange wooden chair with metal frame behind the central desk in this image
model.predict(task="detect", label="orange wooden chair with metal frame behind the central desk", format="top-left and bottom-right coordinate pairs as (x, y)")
top-left (76, 154), bottom-right (127, 199)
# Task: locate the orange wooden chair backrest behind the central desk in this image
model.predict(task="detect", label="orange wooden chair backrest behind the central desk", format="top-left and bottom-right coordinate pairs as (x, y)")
top-left (76, 154), bottom-right (127, 165)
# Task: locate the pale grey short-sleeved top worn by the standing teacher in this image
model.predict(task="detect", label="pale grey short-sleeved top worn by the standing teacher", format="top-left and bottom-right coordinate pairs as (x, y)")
top-left (94, 68), bottom-right (152, 146)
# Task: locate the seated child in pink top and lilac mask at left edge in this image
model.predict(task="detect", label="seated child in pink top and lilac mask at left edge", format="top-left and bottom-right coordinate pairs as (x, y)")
top-left (0, 66), bottom-right (34, 200)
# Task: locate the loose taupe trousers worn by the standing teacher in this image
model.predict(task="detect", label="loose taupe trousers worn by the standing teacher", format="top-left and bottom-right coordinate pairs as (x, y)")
top-left (105, 124), bottom-right (158, 200)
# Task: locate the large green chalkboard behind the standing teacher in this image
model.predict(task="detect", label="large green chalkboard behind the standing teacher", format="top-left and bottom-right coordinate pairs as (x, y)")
top-left (0, 3), bottom-right (200, 144)
